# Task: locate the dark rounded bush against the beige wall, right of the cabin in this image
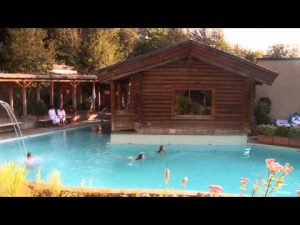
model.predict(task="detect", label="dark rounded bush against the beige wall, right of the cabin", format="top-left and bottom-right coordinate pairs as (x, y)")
top-left (254, 97), bottom-right (272, 125)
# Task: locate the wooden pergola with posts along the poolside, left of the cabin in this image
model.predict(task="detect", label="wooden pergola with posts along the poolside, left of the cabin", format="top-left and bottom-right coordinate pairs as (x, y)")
top-left (0, 73), bottom-right (100, 120)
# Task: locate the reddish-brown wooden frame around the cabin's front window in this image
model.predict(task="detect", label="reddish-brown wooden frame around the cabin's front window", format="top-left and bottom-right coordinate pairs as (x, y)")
top-left (172, 86), bottom-right (216, 120)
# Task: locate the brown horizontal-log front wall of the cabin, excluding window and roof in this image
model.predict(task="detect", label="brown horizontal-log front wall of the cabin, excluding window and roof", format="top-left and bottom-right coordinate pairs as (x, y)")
top-left (131, 60), bottom-right (255, 134)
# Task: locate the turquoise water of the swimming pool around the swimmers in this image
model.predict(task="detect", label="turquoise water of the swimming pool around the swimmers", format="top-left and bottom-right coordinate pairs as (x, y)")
top-left (0, 127), bottom-right (300, 196)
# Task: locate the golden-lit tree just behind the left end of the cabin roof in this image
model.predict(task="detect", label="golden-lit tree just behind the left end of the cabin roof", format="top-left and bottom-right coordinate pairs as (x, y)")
top-left (78, 28), bottom-right (120, 72)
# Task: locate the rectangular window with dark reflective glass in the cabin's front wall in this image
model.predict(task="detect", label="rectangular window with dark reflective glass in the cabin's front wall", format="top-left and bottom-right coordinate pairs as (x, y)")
top-left (175, 90), bottom-right (212, 116)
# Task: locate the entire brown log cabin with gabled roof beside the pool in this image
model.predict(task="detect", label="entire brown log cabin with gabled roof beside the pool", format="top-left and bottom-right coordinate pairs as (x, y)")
top-left (98, 41), bottom-right (278, 134)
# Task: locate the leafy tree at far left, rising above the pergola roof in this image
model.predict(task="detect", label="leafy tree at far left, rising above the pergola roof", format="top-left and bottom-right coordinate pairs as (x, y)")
top-left (0, 28), bottom-right (54, 73)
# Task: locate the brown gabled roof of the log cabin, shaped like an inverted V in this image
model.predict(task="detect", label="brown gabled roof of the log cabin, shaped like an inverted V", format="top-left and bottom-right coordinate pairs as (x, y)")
top-left (98, 40), bottom-right (278, 85)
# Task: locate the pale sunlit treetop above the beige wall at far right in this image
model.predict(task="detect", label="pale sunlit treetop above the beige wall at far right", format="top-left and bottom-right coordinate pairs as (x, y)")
top-left (264, 43), bottom-right (299, 58)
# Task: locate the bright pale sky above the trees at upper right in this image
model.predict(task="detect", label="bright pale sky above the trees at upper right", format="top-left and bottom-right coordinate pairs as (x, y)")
top-left (223, 28), bottom-right (300, 51)
